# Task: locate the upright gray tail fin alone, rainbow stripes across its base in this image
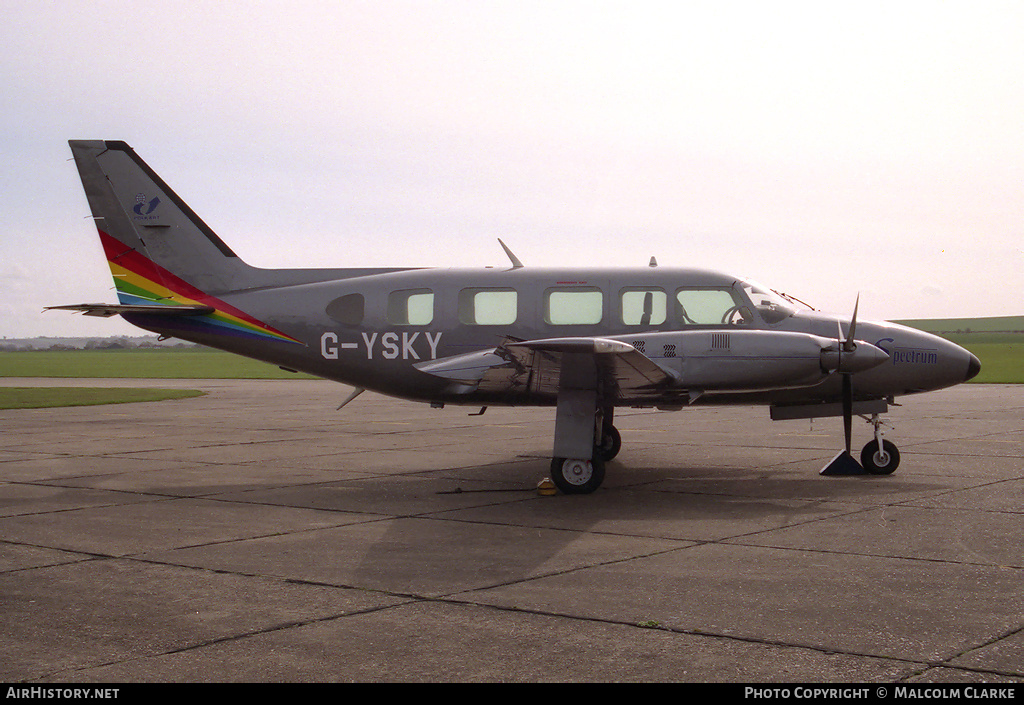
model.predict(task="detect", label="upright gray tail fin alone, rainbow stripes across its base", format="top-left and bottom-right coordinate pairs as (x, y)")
top-left (69, 139), bottom-right (253, 304)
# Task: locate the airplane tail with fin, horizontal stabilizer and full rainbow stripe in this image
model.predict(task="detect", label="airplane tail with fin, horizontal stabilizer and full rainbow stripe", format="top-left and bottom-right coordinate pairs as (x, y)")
top-left (61, 139), bottom-right (301, 346)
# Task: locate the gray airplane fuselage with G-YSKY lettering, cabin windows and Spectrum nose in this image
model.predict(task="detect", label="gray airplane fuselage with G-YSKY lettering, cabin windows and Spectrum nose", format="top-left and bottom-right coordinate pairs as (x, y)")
top-left (126, 267), bottom-right (972, 406)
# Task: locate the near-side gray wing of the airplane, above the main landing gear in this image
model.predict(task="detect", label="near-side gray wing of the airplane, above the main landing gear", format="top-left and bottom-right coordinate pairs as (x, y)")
top-left (417, 337), bottom-right (678, 401)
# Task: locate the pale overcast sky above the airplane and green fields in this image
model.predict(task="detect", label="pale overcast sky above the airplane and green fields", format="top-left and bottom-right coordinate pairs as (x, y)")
top-left (0, 0), bottom-right (1024, 337)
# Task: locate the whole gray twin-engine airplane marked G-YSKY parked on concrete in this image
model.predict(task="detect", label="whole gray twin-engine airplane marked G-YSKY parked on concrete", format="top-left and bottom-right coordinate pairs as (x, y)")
top-left (54, 140), bottom-right (981, 494)
